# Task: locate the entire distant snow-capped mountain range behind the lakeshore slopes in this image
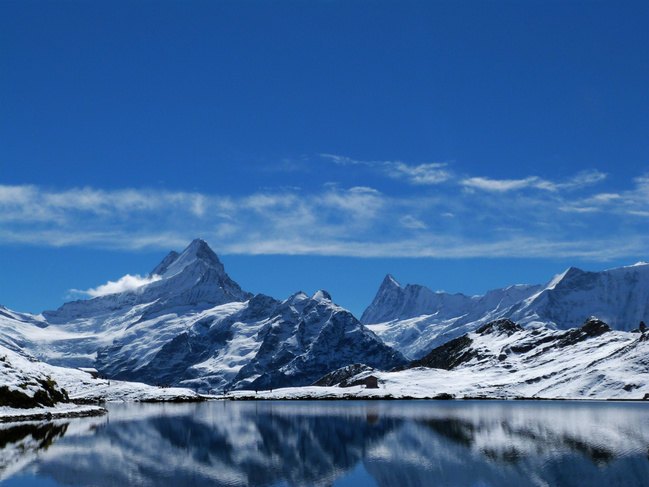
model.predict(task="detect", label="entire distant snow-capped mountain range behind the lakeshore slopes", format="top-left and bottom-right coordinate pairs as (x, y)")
top-left (0, 239), bottom-right (649, 400)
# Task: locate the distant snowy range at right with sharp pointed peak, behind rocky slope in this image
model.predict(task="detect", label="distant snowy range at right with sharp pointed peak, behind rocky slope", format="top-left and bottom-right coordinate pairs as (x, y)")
top-left (361, 263), bottom-right (649, 358)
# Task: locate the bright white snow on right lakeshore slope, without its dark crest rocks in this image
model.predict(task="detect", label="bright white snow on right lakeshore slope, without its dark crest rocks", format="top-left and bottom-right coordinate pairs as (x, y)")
top-left (231, 329), bottom-right (649, 399)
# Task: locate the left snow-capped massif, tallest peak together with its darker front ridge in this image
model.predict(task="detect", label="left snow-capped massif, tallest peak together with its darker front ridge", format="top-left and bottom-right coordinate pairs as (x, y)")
top-left (0, 240), bottom-right (405, 391)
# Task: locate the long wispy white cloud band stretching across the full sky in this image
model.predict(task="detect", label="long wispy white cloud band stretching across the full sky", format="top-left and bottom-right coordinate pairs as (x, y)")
top-left (0, 170), bottom-right (649, 264)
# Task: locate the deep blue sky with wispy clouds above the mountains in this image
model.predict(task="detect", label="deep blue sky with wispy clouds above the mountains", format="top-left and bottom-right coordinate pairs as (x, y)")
top-left (0, 1), bottom-right (649, 313)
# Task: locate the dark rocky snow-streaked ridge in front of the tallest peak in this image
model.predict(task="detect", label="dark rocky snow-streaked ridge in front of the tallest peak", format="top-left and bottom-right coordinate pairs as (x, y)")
top-left (124, 291), bottom-right (405, 390)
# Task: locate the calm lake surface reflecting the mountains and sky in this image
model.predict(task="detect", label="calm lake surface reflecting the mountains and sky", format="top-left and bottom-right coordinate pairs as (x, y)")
top-left (0, 401), bottom-right (649, 487)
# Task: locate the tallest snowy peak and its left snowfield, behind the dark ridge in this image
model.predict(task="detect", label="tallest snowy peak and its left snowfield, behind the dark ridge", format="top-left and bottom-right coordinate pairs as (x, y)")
top-left (0, 240), bottom-right (252, 368)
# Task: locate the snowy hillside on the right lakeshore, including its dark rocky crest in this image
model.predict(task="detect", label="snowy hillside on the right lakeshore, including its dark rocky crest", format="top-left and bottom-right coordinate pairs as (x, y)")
top-left (233, 319), bottom-right (649, 399)
